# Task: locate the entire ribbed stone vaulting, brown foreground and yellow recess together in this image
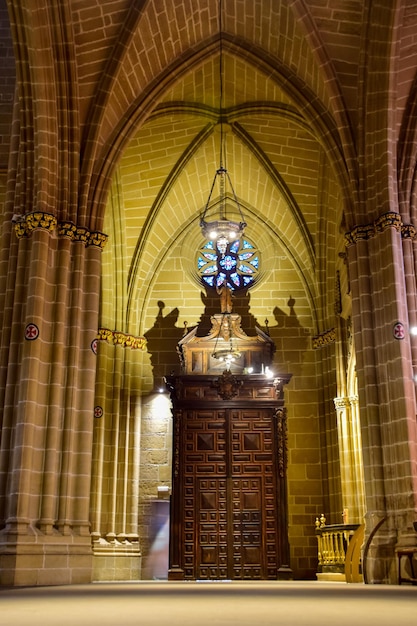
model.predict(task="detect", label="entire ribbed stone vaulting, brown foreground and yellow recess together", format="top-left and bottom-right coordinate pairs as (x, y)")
top-left (4, 0), bottom-right (417, 356)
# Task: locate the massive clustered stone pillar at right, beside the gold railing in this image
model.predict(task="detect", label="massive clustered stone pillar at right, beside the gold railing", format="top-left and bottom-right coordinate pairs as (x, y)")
top-left (348, 213), bottom-right (417, 582)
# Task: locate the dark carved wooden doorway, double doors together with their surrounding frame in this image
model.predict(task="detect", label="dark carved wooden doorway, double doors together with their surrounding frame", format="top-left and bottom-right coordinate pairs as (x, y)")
top-left (166, 370), bottom-right (288, 580)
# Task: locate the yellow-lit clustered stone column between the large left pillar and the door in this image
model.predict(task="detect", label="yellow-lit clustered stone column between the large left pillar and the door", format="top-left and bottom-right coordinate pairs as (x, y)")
top-left (91, 329), bottom-right (146, 580)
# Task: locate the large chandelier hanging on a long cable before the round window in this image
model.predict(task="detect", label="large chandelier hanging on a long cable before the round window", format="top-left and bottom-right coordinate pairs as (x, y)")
top-left (200, 0), bottom-right (246, 258)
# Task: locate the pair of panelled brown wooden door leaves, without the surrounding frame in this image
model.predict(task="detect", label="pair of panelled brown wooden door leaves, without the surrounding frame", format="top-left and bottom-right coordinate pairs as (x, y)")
top-left (184, 409), bottom-right (277, 580)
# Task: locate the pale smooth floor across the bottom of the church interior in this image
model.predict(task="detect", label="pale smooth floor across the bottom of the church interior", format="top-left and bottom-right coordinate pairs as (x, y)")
top-left (0, 581), bottom-right (417, 626)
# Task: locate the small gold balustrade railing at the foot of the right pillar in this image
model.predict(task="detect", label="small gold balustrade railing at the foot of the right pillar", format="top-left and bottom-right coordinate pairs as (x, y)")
top-left (316, 516), bottom-right (364, 582)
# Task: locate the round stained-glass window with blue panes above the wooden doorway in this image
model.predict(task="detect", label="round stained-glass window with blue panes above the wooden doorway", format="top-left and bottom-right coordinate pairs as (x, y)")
top-left (197, 237), bottom-right (259, 290)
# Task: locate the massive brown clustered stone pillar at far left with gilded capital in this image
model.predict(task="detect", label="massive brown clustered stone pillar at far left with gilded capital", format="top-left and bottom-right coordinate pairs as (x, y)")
top-left (0, 212), bottom-right (105, 585)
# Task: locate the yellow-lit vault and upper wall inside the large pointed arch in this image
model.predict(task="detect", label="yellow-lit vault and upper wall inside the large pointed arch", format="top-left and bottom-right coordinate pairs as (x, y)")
top-left (105, 49), bottom-right (342, 342)
